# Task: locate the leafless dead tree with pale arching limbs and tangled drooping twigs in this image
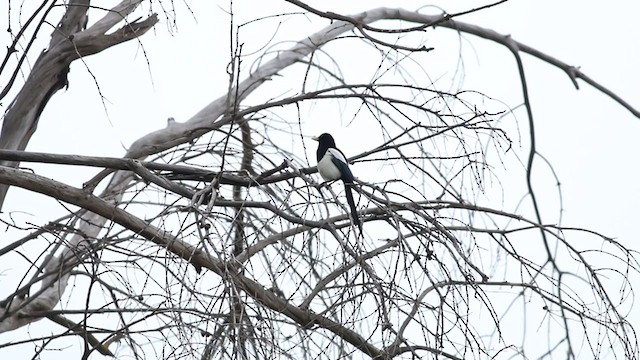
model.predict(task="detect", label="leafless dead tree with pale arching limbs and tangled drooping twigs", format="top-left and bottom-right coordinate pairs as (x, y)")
top-left (0, 0), bottom-right (638, 359)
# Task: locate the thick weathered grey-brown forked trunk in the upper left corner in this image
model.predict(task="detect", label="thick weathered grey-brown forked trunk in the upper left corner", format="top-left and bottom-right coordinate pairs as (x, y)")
top-left (0, 0), bottom-right (158, 208)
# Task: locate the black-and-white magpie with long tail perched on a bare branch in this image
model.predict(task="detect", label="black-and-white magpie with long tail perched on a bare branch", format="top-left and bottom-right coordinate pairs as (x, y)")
top-left (313, 133), bottom-right (362, 234)
